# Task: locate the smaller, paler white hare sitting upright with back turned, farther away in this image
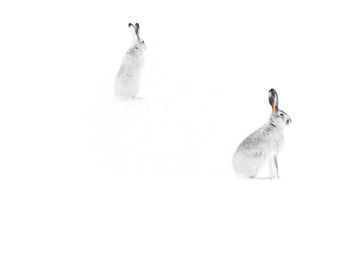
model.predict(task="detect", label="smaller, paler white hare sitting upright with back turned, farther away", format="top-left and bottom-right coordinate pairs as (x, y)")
top-left (114, 23), bottom-right (146, 99)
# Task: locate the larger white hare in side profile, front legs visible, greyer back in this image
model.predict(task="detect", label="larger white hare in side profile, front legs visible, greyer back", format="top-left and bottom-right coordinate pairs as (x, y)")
top-left (233, 89), bottom-right (292, 178)
